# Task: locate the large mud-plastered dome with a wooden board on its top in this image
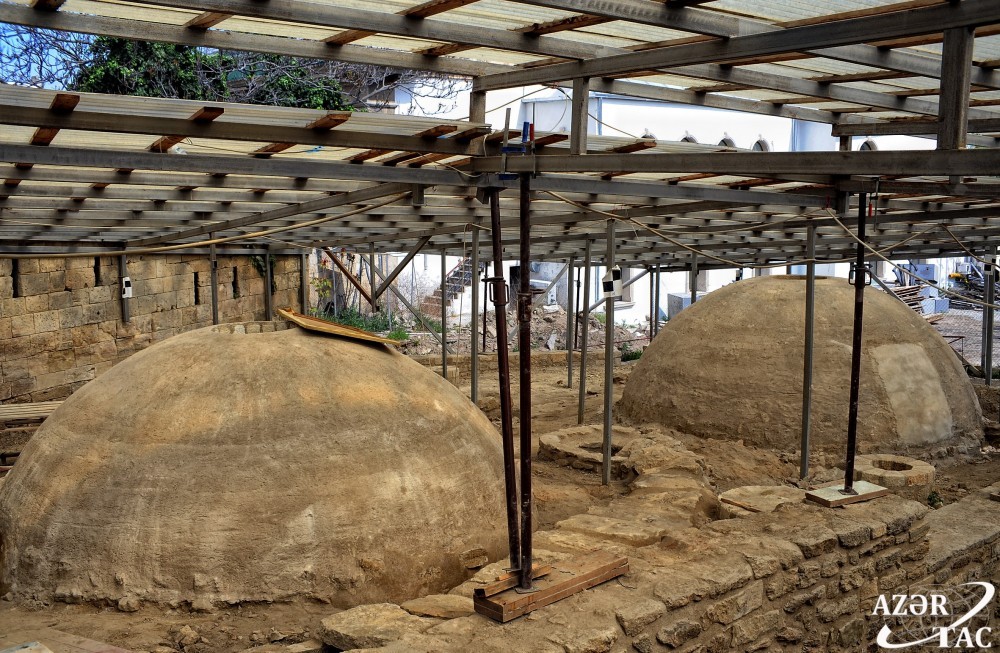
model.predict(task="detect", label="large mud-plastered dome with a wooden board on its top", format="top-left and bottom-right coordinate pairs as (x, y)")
top-left (0, 327), bottom-right (505, 606)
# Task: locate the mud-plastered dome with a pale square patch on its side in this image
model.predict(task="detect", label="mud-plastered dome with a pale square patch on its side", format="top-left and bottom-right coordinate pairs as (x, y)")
top-left (619, 276), bottom-right (982, 451)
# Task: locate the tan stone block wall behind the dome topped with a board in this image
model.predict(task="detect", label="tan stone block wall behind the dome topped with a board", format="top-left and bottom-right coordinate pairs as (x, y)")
top-left (0, 255), bottom-right (301, 402)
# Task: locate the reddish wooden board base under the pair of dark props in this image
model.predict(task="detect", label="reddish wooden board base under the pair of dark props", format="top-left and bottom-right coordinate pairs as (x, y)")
top-left (473, 551), bottom-right (628, 623)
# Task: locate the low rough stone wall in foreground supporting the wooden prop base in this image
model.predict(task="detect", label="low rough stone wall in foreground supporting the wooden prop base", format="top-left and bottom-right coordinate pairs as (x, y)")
top-left (312, 427), bottom-right (1000, 653)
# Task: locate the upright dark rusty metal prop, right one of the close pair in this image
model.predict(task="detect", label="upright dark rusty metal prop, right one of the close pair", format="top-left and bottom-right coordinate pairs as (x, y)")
top-left (517, 175), bottom-right (531, 589)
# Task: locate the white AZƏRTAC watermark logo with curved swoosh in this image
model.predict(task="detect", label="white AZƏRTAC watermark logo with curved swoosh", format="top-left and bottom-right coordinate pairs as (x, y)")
top-left (872, 581), bottom-right (1000, 651)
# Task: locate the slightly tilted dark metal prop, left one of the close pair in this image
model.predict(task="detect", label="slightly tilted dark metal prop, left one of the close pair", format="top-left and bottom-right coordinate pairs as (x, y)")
top-left (483, 189), bottom-right (521, 569)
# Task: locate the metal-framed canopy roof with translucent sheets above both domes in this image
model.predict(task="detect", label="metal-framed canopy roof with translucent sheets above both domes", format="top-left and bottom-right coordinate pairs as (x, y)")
top-left (0, 0), bottom-right (1000, 269)
